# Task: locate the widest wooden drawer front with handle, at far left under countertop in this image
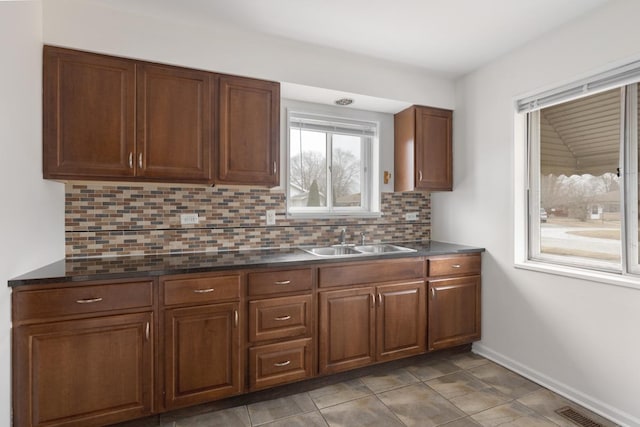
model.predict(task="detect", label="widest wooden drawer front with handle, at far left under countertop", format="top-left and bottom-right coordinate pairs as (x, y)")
top-left (13, 280), bottom-right (153, 322)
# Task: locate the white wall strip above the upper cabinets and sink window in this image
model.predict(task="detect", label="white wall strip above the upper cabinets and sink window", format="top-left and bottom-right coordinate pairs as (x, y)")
top-left (43, 0), bottom-right (454, 112)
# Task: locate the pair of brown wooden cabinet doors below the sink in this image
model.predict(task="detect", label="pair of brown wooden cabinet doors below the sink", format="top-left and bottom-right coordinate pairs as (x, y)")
top-left (319, 281), bottom-right (426, 374)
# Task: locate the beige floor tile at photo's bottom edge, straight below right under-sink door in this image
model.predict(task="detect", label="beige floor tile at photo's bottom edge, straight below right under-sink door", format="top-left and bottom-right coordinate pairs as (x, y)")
top-left (378, 383), bottom-right (466, 427)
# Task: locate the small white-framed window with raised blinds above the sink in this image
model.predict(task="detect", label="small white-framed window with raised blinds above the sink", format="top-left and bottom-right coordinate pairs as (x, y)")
top-left (287, 111), bottom-right (380, 217)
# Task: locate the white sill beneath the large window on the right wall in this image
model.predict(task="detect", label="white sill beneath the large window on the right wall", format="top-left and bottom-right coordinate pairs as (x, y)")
top-left (514, 260), bottom-right (640, 290)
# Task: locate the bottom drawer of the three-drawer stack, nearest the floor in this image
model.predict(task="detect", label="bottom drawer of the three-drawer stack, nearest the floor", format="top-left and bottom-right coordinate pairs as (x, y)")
top-left (249, 338), bottom-right (312, 390)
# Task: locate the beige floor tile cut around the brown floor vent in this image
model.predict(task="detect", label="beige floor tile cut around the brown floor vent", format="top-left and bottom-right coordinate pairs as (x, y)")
top-left (518, 388), bottom-right (617, 427)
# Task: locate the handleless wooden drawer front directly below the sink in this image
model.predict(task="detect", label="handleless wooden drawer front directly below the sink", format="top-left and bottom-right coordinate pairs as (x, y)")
top-left (318, 258), bottom-right (424, 288)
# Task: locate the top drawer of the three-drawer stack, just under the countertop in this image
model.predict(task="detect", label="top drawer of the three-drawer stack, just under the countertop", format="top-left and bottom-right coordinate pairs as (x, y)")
top-left (248, 268), bottom-right (313, 296)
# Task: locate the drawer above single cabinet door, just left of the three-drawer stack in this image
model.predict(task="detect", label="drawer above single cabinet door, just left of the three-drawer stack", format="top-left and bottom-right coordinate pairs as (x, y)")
top-left (162, 274), bottom-right (240, 305)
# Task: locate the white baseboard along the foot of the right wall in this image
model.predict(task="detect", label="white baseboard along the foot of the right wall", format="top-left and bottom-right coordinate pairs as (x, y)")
top-left (472, 342), bottom-right (640, 427)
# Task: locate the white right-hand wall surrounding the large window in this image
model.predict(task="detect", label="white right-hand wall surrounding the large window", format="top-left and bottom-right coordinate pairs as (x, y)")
top-left (432, 0), bottom-right (640, 425)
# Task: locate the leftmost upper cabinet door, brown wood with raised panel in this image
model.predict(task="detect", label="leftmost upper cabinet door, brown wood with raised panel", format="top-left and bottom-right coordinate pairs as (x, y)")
top-left (43, 46), bottom-right (135, 179)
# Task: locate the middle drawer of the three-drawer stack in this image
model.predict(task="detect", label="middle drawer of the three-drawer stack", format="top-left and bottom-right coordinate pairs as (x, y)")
top-left (249, 295), bottom-right (312, 342)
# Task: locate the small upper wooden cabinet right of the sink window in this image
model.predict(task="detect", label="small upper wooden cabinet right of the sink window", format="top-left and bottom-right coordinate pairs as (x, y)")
top-left (394, 106), bottom-right (453, 191)
